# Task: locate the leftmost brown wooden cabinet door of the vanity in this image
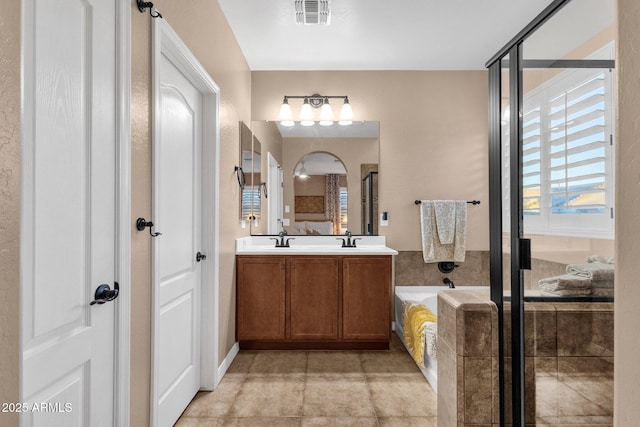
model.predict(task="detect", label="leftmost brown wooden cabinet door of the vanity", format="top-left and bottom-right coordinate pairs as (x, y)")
top-left (236, 257), bottom-right (285, 340)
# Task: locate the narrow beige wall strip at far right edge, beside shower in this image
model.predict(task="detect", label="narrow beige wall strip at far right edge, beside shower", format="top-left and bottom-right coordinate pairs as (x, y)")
top-left (614, 0), bottom-right (640, 427)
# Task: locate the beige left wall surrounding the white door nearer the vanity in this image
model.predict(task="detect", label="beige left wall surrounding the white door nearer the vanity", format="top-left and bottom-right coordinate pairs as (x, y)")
top-left (131, 0), bottom-right (251, 426)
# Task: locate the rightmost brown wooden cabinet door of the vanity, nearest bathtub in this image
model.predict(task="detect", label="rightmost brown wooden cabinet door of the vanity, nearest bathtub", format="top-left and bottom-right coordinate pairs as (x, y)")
top-left (342, 257), bottom-right (391, 340)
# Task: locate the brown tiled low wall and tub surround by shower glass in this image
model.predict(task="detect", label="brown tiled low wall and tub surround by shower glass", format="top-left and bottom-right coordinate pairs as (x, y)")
top-left (438, 291), bottom-right (613, 427)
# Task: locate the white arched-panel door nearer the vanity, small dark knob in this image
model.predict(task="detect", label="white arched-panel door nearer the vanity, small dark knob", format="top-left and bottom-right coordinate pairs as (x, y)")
top-left (153, 39), bottom-right (204, 426)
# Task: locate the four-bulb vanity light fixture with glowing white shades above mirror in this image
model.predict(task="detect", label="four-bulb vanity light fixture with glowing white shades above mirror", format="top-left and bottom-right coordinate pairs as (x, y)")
top-left (278, 93), bottom-right (353, 126)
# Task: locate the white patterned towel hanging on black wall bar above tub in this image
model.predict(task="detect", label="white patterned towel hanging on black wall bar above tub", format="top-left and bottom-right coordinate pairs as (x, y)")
top-left (420, 200), bottom-right (467, 263)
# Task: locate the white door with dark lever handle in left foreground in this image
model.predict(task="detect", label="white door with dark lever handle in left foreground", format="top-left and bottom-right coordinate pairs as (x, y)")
top-left (21, 0), bottom-right (118, 427)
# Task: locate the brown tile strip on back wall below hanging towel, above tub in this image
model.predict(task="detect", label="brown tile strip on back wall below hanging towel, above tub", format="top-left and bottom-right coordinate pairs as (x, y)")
top-left (395, 251), bottom-right (489, 286)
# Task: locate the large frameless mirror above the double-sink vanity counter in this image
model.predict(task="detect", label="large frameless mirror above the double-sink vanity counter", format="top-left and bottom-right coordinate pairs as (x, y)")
top-left (251, 121), bottom-right (379, 235)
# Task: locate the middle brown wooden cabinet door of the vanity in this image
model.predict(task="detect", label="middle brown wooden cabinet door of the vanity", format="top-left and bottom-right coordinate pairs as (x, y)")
top-left (290, 256), bottom-right (340, 340)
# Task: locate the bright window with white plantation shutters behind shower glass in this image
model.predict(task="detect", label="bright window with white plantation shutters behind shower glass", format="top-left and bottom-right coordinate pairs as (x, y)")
top-left (503, 49), bottom-right (614, 238)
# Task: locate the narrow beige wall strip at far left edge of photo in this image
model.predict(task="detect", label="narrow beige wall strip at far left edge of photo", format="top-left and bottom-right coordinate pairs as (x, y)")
top-left (0, 0), bottom-right (20, 426)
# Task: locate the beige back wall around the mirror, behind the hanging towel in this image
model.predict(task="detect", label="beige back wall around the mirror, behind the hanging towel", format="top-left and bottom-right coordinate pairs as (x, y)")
top-left (251, 71), bottom-right (489, 250)
